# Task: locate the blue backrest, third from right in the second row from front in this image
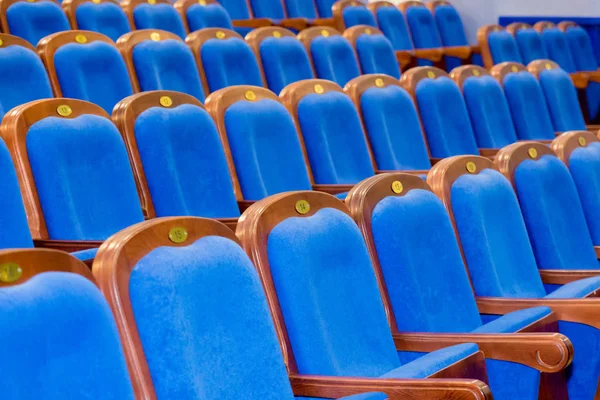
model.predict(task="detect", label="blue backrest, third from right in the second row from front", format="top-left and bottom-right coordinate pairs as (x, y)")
top-left (463, 75), bottom-right (517, 149)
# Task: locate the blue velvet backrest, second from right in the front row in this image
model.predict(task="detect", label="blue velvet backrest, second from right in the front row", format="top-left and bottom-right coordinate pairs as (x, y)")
top-left (514, 155), bottom-right (598, 269)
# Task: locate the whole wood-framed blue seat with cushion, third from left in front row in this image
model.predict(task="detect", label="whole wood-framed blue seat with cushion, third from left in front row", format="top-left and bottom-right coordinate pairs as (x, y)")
top-left (237, 192), bottom-right (491, 400)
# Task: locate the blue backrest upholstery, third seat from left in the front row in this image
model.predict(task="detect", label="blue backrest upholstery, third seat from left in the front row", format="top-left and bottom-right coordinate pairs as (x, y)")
top-left (267, 208), bottom-right (400, 377)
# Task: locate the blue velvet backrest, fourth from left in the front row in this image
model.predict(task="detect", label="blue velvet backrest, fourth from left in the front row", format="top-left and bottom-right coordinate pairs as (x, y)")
top-left (371, 189), bottom-right (481, 332)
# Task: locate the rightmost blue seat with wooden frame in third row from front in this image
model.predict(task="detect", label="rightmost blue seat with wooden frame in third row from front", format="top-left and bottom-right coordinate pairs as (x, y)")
top-left (344, 25), bottom-right (400, 79)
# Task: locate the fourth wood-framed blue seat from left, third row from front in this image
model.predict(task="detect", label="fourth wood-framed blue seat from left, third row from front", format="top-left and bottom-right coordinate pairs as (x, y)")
top-left (185, 28), bottom-right (264, 94)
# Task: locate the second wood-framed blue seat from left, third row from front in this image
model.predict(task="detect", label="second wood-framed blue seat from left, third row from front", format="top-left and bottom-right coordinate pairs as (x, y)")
top-left (38, 31), bottom-right (133, 114)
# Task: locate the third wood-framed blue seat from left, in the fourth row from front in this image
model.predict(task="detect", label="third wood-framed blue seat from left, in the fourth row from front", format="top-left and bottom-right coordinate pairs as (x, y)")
top-left (121, 0), bottom-right (187, 39)
